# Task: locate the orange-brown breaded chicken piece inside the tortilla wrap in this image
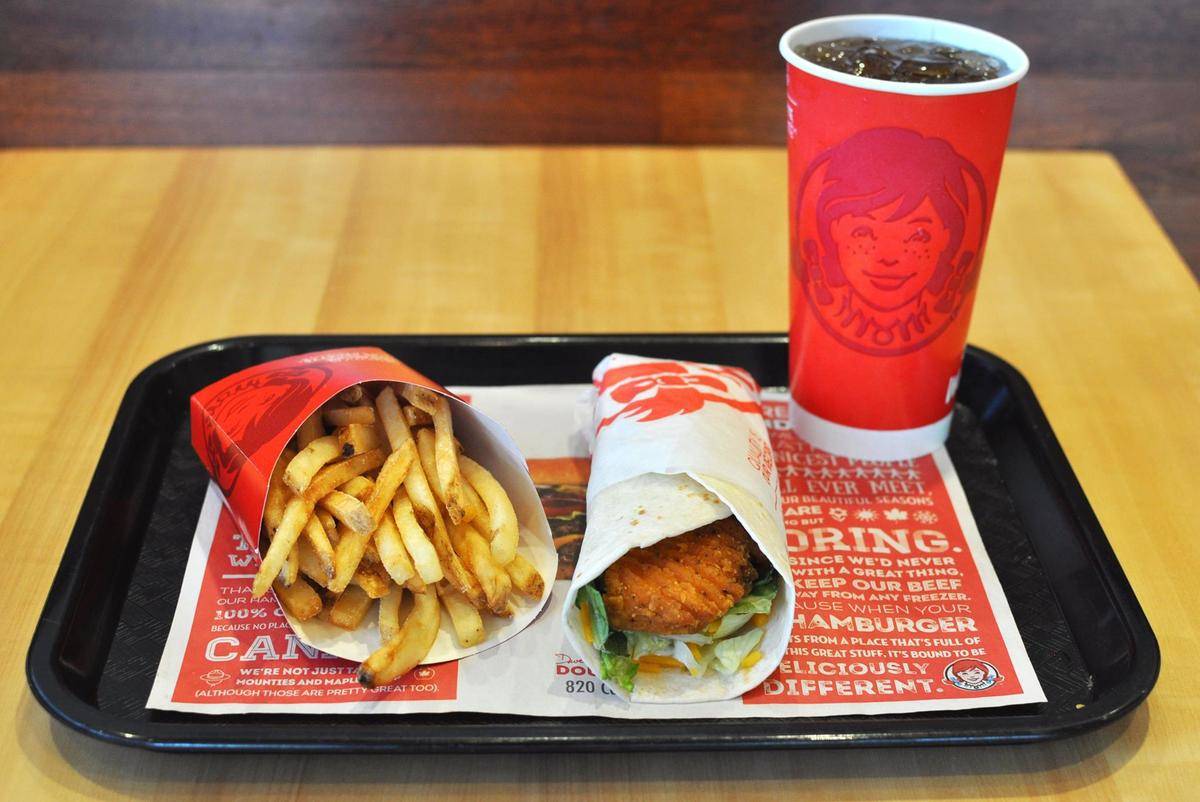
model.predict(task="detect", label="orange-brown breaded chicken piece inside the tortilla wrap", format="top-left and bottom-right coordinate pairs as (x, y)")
top-left (602, 515), bottom-right (758, 635)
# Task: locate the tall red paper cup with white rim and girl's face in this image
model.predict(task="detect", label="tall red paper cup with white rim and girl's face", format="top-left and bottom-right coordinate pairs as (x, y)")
top-left (779, 14), bottom-right (1028, 460)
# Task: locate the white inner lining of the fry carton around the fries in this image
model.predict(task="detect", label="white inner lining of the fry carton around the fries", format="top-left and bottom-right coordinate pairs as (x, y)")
top-left (281, 385), bottom-right (558, 665)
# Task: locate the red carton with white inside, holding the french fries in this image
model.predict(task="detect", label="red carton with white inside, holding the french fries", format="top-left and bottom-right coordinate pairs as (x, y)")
top-left (191, 347), bottom-right (557, 663)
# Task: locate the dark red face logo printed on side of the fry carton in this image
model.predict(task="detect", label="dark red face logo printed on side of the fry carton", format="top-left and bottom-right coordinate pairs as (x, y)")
top-left (203, 365), bottom-right (331, 497)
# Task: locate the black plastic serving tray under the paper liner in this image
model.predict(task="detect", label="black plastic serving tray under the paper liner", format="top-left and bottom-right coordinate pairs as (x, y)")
top-left (26, 335), bottom-right (1159, 753)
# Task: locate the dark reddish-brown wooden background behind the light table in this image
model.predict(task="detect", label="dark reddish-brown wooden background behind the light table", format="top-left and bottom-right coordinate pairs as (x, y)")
top-left (0, 0), bottom-right (1200, 269)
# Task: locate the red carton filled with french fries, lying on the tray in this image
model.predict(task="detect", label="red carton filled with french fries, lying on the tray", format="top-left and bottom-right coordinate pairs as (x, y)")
top-left (192, 347), bottom-right (557, 687)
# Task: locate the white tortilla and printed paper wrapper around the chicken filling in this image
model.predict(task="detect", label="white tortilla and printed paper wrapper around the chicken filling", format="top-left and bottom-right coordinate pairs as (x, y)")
top-left (563, 354), bottom-right (796, 702)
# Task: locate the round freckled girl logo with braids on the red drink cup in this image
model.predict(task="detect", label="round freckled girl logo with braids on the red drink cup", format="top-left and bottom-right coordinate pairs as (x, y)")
top-left (792, 128), bottom-right (988, 357)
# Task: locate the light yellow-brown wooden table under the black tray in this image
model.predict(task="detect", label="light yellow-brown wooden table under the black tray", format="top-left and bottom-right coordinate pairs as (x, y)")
top-left (0, 148), bottom-right (1200, 801)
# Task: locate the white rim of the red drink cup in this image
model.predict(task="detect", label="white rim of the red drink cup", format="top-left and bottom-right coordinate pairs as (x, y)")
top-left (779, 14), bottom-right (1030, 97)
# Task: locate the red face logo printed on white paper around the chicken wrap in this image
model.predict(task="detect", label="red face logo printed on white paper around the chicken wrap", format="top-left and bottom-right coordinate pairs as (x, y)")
top-left (596, 361), bottom-right (762, 432)
